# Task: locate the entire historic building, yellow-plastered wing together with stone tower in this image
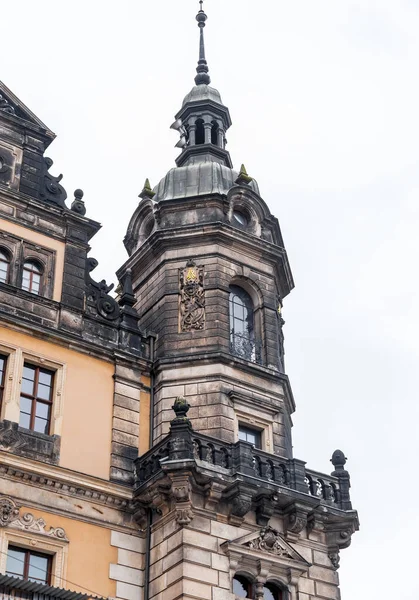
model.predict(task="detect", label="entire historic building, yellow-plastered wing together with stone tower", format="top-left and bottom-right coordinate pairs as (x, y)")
top-left (0, 3), bottom-right (358, 600)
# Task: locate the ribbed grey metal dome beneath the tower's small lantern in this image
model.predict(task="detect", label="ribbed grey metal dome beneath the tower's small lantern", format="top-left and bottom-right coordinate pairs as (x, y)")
top-left (153, 161), bottom-right (259, 202)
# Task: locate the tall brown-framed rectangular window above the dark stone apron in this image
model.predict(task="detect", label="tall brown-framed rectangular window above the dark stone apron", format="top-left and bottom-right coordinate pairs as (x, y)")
top-left (19, 363), bottom-right (54, 434)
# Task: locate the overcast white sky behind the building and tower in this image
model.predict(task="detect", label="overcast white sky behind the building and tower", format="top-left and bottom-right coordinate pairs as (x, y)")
top-left (0, 0), bottom-right (419, 600)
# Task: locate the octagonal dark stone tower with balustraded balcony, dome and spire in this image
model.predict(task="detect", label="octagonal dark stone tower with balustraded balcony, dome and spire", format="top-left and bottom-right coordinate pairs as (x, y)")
top-left (123, 2), bottom-right (358, 600)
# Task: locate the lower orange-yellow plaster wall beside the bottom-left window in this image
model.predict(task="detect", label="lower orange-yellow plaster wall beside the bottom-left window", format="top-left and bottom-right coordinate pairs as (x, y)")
top-left (20, 507), bottom-right (118, 598)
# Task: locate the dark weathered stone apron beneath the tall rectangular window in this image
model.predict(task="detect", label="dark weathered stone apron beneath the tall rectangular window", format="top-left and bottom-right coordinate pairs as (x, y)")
top-left (0, 420), bottom-right (61, 465)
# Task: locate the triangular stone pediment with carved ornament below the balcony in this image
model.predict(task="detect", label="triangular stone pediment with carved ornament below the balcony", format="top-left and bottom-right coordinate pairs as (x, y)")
top-left (226, 527), bottom-right (310, 568)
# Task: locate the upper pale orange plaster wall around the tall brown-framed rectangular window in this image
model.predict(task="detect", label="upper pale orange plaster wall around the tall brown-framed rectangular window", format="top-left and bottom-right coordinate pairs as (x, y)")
top-left (0, 326), bottom-right (114, 479)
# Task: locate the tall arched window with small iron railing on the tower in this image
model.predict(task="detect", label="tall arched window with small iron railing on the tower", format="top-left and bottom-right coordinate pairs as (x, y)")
top-left (230, 285), bottom-right (255, 362)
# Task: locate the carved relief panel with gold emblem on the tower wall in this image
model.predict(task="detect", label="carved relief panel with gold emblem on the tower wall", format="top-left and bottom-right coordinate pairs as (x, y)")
top-left (179, 260), bottom-right (205, 332)
